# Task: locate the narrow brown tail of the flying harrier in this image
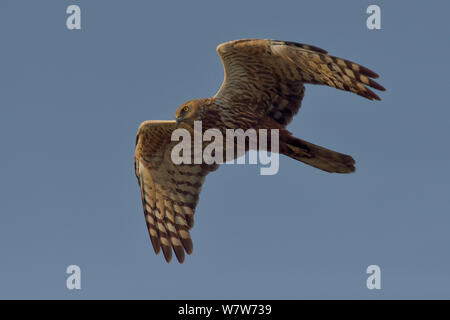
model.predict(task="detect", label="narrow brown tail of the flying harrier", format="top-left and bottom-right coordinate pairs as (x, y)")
top-left (280, 130), bottom-right (355, 173)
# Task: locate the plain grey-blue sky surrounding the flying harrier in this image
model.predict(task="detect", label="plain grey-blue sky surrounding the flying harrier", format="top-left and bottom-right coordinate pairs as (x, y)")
top-left (0, 0), bottom-right (450, 299)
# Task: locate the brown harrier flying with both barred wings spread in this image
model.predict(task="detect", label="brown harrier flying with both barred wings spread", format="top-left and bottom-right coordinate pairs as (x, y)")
top-left (134, 39), bottom-right (385, 263)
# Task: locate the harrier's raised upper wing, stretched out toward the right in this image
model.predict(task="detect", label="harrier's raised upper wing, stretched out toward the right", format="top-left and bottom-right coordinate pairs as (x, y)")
top-left (215, 39), bottom-right (385, 125)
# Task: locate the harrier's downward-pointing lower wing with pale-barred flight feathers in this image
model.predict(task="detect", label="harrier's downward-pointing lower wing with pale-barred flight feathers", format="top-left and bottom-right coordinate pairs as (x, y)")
top-left (134, 121), bottom-right (218, 263)
